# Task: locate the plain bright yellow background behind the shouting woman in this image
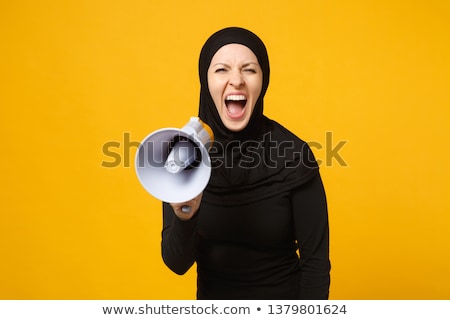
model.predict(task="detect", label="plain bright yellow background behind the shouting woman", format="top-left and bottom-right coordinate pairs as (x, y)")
top-left (0, 0), bottom-right (450, 299)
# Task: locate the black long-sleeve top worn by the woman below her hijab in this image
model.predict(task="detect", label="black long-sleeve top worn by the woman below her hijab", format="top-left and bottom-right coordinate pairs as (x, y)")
top-left (162, 173), bottom-right (330, 299)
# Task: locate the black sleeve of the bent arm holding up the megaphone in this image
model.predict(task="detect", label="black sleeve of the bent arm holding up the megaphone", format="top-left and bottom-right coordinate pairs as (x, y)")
top-left (161, 203), bottom-right (198, 275)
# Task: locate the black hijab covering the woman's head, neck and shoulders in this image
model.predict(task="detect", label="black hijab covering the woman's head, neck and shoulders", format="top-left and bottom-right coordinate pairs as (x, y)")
top-left (199, 27), bottom-right (318, 205)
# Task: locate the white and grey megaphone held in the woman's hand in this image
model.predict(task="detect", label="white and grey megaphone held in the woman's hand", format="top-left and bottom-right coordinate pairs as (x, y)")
top-left (135, 117), bottom-right (214, 205)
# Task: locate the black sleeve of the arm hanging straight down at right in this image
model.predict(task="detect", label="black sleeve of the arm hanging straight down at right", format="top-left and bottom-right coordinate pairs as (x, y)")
top-left (292, 174), bottom-right (331, 300)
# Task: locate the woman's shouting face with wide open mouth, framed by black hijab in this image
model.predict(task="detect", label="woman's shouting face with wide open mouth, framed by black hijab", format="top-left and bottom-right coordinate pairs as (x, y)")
top-left (208, 43), bottom-right (263, 132)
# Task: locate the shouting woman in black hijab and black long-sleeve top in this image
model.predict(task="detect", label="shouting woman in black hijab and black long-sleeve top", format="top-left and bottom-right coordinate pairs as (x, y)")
top-left (162, 27), bottom-right (330, 299)
